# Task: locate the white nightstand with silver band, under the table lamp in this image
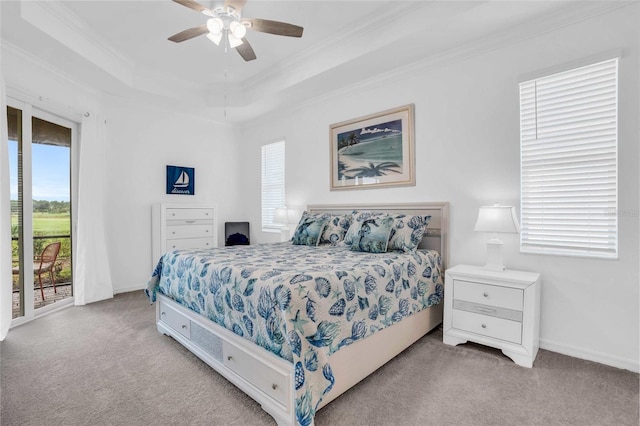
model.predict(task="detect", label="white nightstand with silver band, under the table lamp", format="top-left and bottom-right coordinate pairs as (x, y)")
top-left (443, 265), bottom-right (540, 368)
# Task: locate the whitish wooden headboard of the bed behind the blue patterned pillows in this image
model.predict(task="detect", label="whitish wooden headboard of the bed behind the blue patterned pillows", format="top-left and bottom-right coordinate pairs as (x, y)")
top-left (306, 202), bottom-right (449, 272)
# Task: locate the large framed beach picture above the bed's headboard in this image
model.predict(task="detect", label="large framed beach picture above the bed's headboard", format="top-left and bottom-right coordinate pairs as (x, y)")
top-left (330, 104), bottom-right (416, 191)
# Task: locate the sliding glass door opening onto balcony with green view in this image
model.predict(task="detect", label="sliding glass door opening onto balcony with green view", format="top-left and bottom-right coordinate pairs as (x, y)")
top-left (7, 99), bottom-right (77, 319)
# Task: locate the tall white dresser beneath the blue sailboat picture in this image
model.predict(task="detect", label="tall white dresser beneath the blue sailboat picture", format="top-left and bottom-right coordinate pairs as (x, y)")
top-left (151, 203), bottom-right (218, 266)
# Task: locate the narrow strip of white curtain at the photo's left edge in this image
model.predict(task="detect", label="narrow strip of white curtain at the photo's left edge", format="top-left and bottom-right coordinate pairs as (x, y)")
top-left (0, 71), bottom-right (13, 340)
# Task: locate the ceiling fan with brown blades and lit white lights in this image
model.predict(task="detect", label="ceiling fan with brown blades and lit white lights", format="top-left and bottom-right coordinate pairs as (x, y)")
top-left (169, 0), bottom-right (303, 61)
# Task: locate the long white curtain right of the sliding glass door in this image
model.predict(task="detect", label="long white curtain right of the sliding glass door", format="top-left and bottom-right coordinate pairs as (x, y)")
top-left (74, 114), bottom-right (113, 305)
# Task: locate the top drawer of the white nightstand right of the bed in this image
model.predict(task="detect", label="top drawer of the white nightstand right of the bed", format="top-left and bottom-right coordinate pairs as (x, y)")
top-left (453, 280), bottom-right (524, 311)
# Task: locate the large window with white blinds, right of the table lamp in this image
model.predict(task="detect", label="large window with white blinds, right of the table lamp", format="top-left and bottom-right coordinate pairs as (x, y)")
top-left (520, 58), bottom-right (618, 258)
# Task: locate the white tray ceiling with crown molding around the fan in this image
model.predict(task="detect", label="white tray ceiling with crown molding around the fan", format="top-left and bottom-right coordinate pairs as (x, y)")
top-left (0, 0), bottom-right (611, 122)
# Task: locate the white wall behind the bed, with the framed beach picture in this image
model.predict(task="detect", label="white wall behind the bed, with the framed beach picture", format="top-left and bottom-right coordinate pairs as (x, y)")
top-left (240, 4), bottom-right (640, 371)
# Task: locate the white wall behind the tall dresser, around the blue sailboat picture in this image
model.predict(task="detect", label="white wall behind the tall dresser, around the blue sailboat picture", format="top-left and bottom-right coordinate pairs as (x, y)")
top-left (104, 99), bottom-right (239, 293)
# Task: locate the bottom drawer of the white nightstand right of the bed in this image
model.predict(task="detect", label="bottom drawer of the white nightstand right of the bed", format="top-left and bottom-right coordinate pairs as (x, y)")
top-left (452, 309), bottom-right (522, 344)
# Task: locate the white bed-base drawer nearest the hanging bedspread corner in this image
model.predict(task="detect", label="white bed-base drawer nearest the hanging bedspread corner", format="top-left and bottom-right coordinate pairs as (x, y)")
top-left (222, 341), bottom-right (290, 406)
